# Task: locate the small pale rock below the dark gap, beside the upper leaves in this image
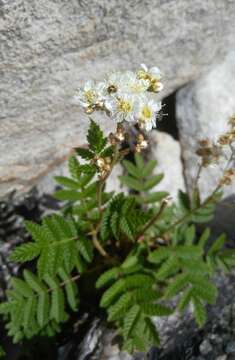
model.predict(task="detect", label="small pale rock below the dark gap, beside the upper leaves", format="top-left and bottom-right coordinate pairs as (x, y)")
top-left (150, 131), bottom-right (185, 199)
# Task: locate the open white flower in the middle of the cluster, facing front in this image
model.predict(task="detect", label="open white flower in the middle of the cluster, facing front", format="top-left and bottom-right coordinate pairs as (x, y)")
top-left (105, 94), bottom-right (138, 122)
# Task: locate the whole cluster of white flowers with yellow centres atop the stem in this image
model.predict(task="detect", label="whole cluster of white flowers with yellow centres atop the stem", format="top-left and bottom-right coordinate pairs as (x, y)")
top-left (75, 64), bottom-right (163, 131)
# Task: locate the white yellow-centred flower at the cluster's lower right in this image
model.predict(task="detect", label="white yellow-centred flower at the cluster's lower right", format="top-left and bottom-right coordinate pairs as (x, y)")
top-left (137, 99), bottom-right (161, 131)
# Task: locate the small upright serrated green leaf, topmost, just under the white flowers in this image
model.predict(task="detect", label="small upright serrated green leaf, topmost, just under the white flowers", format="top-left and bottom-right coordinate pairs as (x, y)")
top-left (87, 119), bottom-right (107, 153)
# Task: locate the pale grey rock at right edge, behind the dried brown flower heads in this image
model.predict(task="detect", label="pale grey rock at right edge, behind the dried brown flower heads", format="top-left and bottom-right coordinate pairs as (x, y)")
top-left (176, 51), bottom-right (235, 201)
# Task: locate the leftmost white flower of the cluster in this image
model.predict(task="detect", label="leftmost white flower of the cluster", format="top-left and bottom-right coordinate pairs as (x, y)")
top-left (74, 81), bottom-right (105, 108)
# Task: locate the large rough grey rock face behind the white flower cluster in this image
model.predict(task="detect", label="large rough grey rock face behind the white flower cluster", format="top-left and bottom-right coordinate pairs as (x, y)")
top-left (0, 0), bottom-right (235, 195)
